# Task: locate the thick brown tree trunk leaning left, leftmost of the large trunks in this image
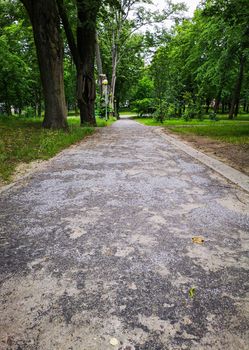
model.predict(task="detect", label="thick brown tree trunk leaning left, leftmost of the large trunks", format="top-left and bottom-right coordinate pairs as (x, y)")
top-left (21, 0), bottom-right (67, 129)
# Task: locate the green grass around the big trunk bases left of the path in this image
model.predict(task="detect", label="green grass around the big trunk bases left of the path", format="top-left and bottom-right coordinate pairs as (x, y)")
top-left (0, 117), bottom-right (113, 182)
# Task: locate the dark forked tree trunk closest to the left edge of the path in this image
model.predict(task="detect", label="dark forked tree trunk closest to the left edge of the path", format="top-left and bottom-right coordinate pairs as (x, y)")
top-left (57, 0), bottom-right (101, 126)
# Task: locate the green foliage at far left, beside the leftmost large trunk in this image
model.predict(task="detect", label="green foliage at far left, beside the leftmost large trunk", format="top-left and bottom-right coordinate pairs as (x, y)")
top-left (0, 1), bottom-right (41, 114)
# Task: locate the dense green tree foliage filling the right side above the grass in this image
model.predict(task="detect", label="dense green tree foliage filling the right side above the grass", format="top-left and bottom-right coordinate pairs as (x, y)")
top-left (150, 0), bottom-right (249, 120)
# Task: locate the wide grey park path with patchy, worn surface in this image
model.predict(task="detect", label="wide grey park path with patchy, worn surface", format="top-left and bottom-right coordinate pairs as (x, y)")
top-left (0, 120), bottom-right (249, 350)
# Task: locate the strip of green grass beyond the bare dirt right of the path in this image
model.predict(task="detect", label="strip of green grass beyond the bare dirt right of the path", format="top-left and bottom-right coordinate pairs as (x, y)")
top-left (170, 123), bottom-right (249, 145)
